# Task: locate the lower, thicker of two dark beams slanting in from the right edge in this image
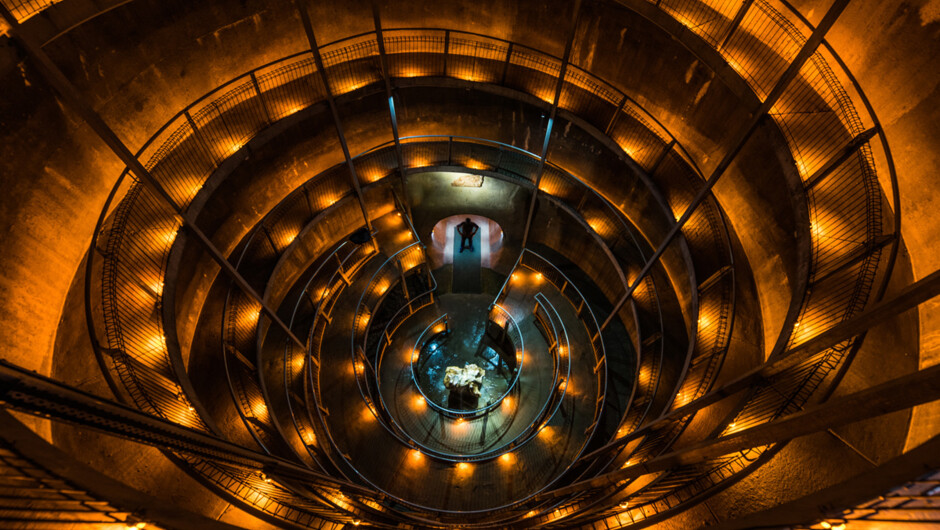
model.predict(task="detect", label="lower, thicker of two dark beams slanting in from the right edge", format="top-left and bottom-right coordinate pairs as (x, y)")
top-left (550, 356), bottom-right (940, 496)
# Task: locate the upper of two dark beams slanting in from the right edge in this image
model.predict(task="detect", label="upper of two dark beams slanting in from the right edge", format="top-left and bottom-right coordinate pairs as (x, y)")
top-left (583, 270), bottom-right (940, 459)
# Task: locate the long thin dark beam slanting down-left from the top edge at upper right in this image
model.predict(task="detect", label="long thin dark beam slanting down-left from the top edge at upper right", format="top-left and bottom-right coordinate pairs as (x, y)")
top-left (601, 0), bottom-right (850, 329)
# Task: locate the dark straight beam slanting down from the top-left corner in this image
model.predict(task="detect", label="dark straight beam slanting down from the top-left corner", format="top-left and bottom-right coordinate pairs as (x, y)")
top-left (0, 4), bottom-right (306, 348)
